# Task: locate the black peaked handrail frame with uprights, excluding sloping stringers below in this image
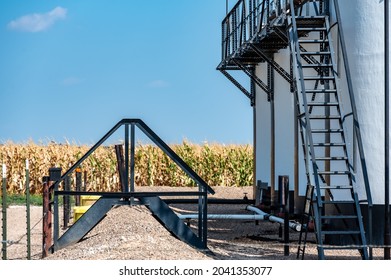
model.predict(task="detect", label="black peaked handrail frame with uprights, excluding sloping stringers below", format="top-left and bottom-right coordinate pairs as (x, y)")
top-left (49, 119), bottom-right (215, 249)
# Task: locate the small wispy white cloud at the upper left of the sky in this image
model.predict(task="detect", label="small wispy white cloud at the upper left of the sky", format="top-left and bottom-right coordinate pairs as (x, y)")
top-left (8, 7), bottom-right (67, 32)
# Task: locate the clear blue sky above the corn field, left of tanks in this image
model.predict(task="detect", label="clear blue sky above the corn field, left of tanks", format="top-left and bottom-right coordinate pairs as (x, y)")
top-left (0, 0), bottom-right (252, 144)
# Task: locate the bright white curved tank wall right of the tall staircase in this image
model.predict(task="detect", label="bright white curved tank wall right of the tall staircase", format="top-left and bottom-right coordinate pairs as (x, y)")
top-left (332, 0), bottom-right (390, 204)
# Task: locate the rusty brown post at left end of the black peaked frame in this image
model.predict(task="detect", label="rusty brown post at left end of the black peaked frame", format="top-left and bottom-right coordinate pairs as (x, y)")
top-left (42, 176), bottom-right (52, 258)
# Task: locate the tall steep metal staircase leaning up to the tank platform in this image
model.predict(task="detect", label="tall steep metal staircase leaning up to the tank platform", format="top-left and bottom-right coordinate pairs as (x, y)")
top-left (288, 0), bottom-right (368, 259)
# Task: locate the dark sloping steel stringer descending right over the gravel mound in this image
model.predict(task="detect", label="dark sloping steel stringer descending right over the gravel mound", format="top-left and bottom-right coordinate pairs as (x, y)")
top-left (140, 196), bottom-right (206, 249)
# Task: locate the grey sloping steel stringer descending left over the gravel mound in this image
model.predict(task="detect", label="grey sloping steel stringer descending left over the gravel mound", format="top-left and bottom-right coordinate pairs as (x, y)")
top-left (54, 197), bottom-right (119, 251)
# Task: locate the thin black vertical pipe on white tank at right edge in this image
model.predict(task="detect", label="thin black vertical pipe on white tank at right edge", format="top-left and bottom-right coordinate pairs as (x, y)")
top-left (384, 0), bottom-right (391, 260)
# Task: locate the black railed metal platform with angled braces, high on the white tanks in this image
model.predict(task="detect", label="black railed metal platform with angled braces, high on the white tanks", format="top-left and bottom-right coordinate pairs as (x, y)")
top-left (217, 0), bottom-right (292, 106)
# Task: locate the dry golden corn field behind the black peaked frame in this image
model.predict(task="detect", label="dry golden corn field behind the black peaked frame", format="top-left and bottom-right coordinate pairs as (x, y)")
top-left (0, 141), bottom-right (253, 194)
